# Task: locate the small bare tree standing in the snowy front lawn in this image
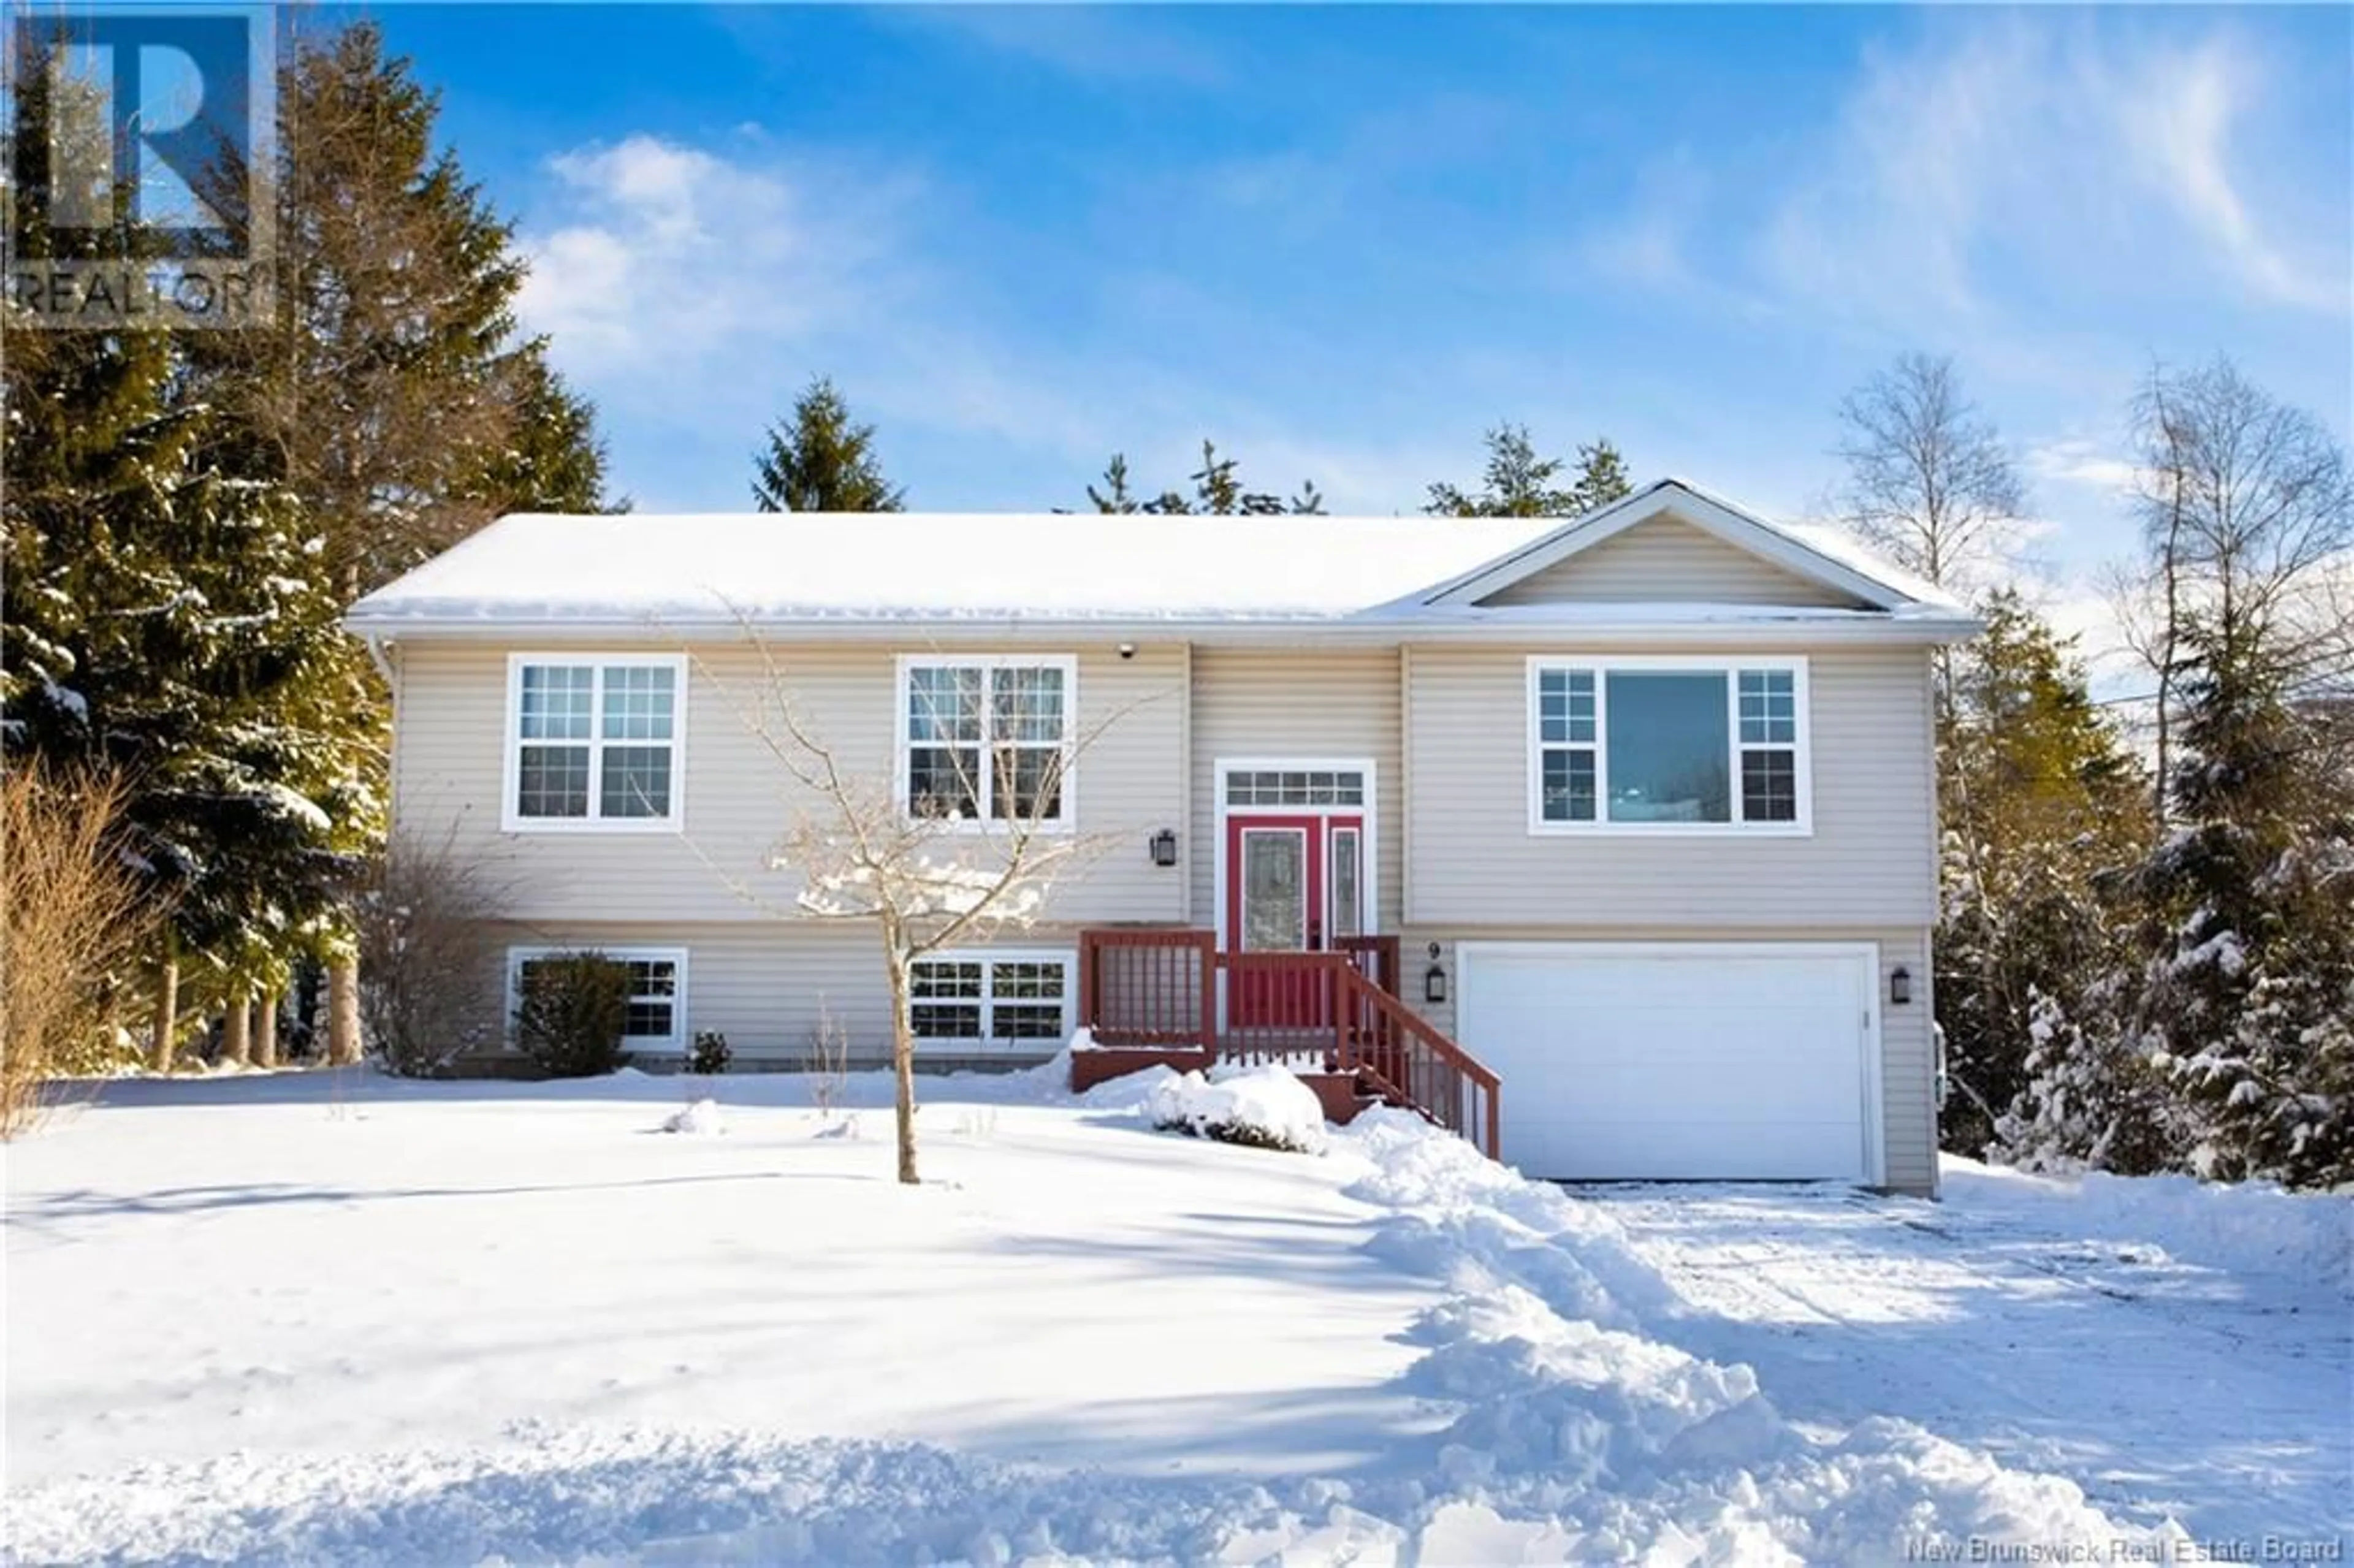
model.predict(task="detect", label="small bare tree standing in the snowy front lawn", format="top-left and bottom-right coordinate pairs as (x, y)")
top-left (723, 636), bottom-right (1127, 1184)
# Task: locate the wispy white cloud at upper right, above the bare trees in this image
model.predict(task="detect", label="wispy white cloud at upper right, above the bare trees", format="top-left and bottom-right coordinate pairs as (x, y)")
top-left (1586, 9), bottom-right (2354, 332)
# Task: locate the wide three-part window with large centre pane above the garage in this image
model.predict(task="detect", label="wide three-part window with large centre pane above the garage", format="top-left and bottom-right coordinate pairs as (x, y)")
top-left (1528, 659), bottom-right (1810, 834)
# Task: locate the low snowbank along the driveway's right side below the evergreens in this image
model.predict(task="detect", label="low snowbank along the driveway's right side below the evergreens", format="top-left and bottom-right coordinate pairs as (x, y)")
top-left (1940, 1154), bottom-right (2354, 1297)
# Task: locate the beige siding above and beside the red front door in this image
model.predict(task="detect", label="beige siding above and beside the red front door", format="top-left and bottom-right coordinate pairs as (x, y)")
top-left (1186, 647), bottom-right (1405, 930)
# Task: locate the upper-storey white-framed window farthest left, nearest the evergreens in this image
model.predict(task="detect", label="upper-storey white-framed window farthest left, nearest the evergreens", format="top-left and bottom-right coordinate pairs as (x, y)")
top-left (504, 655), bottom-right (685, 831)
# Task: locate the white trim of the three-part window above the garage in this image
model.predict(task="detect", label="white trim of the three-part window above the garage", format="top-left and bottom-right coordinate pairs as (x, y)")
top-left (1523, 655), bottom-right (1815, 838)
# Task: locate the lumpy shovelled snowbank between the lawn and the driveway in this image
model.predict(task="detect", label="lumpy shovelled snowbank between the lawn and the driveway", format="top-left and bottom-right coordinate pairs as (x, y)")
top-left (1344, 1111), bottom-right (2147, 1563)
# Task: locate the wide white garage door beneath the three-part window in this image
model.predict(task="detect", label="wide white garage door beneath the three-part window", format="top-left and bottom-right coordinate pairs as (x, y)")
top-left (1457, 942), bottom-right (1878, 1182)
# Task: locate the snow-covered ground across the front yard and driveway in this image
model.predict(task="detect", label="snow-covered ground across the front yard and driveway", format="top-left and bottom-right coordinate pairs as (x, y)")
top-left (7, 1054), bottom-right (2347, 1568)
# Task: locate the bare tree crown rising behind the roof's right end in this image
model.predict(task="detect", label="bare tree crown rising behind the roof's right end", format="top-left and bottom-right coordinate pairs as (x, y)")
top-left (1836, 353), bottom-right (2027, 593)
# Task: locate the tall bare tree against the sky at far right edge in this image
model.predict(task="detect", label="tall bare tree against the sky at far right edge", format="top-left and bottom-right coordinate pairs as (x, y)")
top-left (2119, 358), bottom-right (2354, 817)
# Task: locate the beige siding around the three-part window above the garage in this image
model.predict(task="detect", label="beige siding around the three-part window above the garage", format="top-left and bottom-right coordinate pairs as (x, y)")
top-left (1403, 645), bottom-right (1937, 937)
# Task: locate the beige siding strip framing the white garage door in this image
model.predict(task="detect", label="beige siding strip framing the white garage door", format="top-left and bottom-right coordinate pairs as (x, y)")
top-left (1401, 921), bottom-right (1937, 1196)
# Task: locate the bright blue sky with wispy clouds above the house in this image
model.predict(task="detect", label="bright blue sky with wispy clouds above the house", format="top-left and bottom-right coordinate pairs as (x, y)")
top-left (362, 5), bottom-right (2354, 645)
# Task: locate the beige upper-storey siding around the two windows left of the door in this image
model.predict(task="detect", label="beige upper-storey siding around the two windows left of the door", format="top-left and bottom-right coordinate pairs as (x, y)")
top-left (393, 641), bottom-right (1186, 923)
